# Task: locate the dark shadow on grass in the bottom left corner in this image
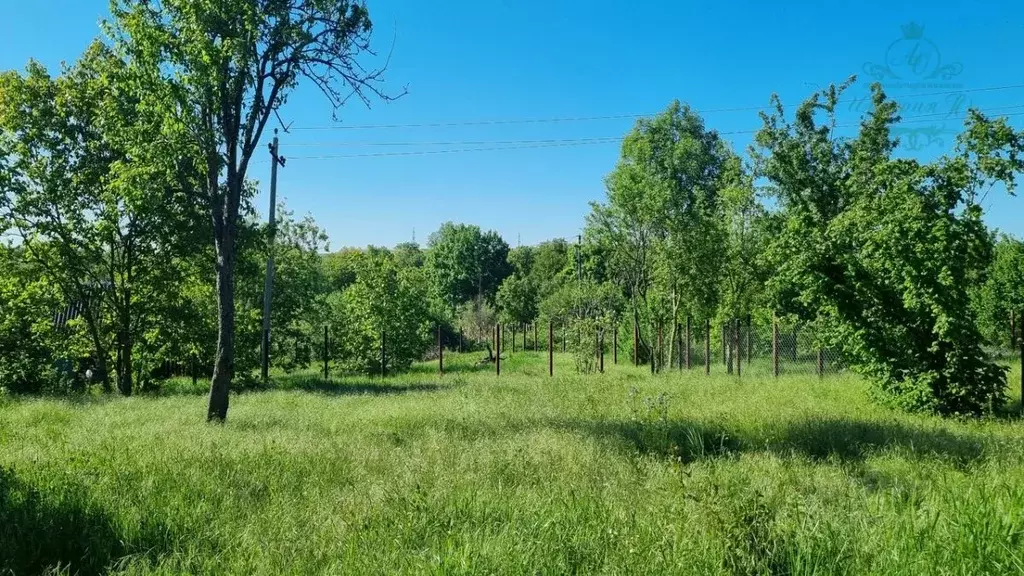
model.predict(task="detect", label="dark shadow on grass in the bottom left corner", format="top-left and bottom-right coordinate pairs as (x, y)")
top-left (0, 467), bottom-right (174, 576)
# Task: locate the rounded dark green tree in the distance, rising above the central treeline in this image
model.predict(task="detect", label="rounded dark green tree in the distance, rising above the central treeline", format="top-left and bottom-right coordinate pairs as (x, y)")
top-left (425, 222), bottom-right (512, 311)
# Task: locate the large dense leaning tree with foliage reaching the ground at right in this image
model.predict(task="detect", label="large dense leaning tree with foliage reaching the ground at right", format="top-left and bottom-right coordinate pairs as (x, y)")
top-left (757, 80), bottom-right (1024, 414)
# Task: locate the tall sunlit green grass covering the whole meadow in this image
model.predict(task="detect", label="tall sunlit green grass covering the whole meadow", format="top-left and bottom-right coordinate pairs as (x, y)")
top-left (0, 353), bottom-right (1024, 575)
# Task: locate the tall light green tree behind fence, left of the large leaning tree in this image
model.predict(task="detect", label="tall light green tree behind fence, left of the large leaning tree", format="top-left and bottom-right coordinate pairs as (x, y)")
top-left (585, 101), bottom-right (734, 364)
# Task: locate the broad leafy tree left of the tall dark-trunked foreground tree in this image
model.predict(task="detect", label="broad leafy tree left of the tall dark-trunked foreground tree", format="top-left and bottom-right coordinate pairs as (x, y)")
top-left (0, 42), bottom-right (204, 396)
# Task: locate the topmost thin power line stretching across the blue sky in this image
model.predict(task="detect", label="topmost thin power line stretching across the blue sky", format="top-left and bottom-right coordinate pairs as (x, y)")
top-left (290, 84), bottom-right (1024, 131)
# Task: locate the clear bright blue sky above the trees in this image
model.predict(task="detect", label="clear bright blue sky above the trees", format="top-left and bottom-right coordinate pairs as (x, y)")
top-left (0, 0), bottom-right (1024, 248)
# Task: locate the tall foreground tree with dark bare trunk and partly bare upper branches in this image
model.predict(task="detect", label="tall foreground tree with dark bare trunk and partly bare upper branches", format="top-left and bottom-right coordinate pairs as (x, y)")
top-left (109, 0), bottom-right (401, 421)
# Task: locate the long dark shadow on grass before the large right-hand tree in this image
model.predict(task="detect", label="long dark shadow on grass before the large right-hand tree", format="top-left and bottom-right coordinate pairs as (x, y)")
top-left (568, 412), bottom-right (985, 467)
